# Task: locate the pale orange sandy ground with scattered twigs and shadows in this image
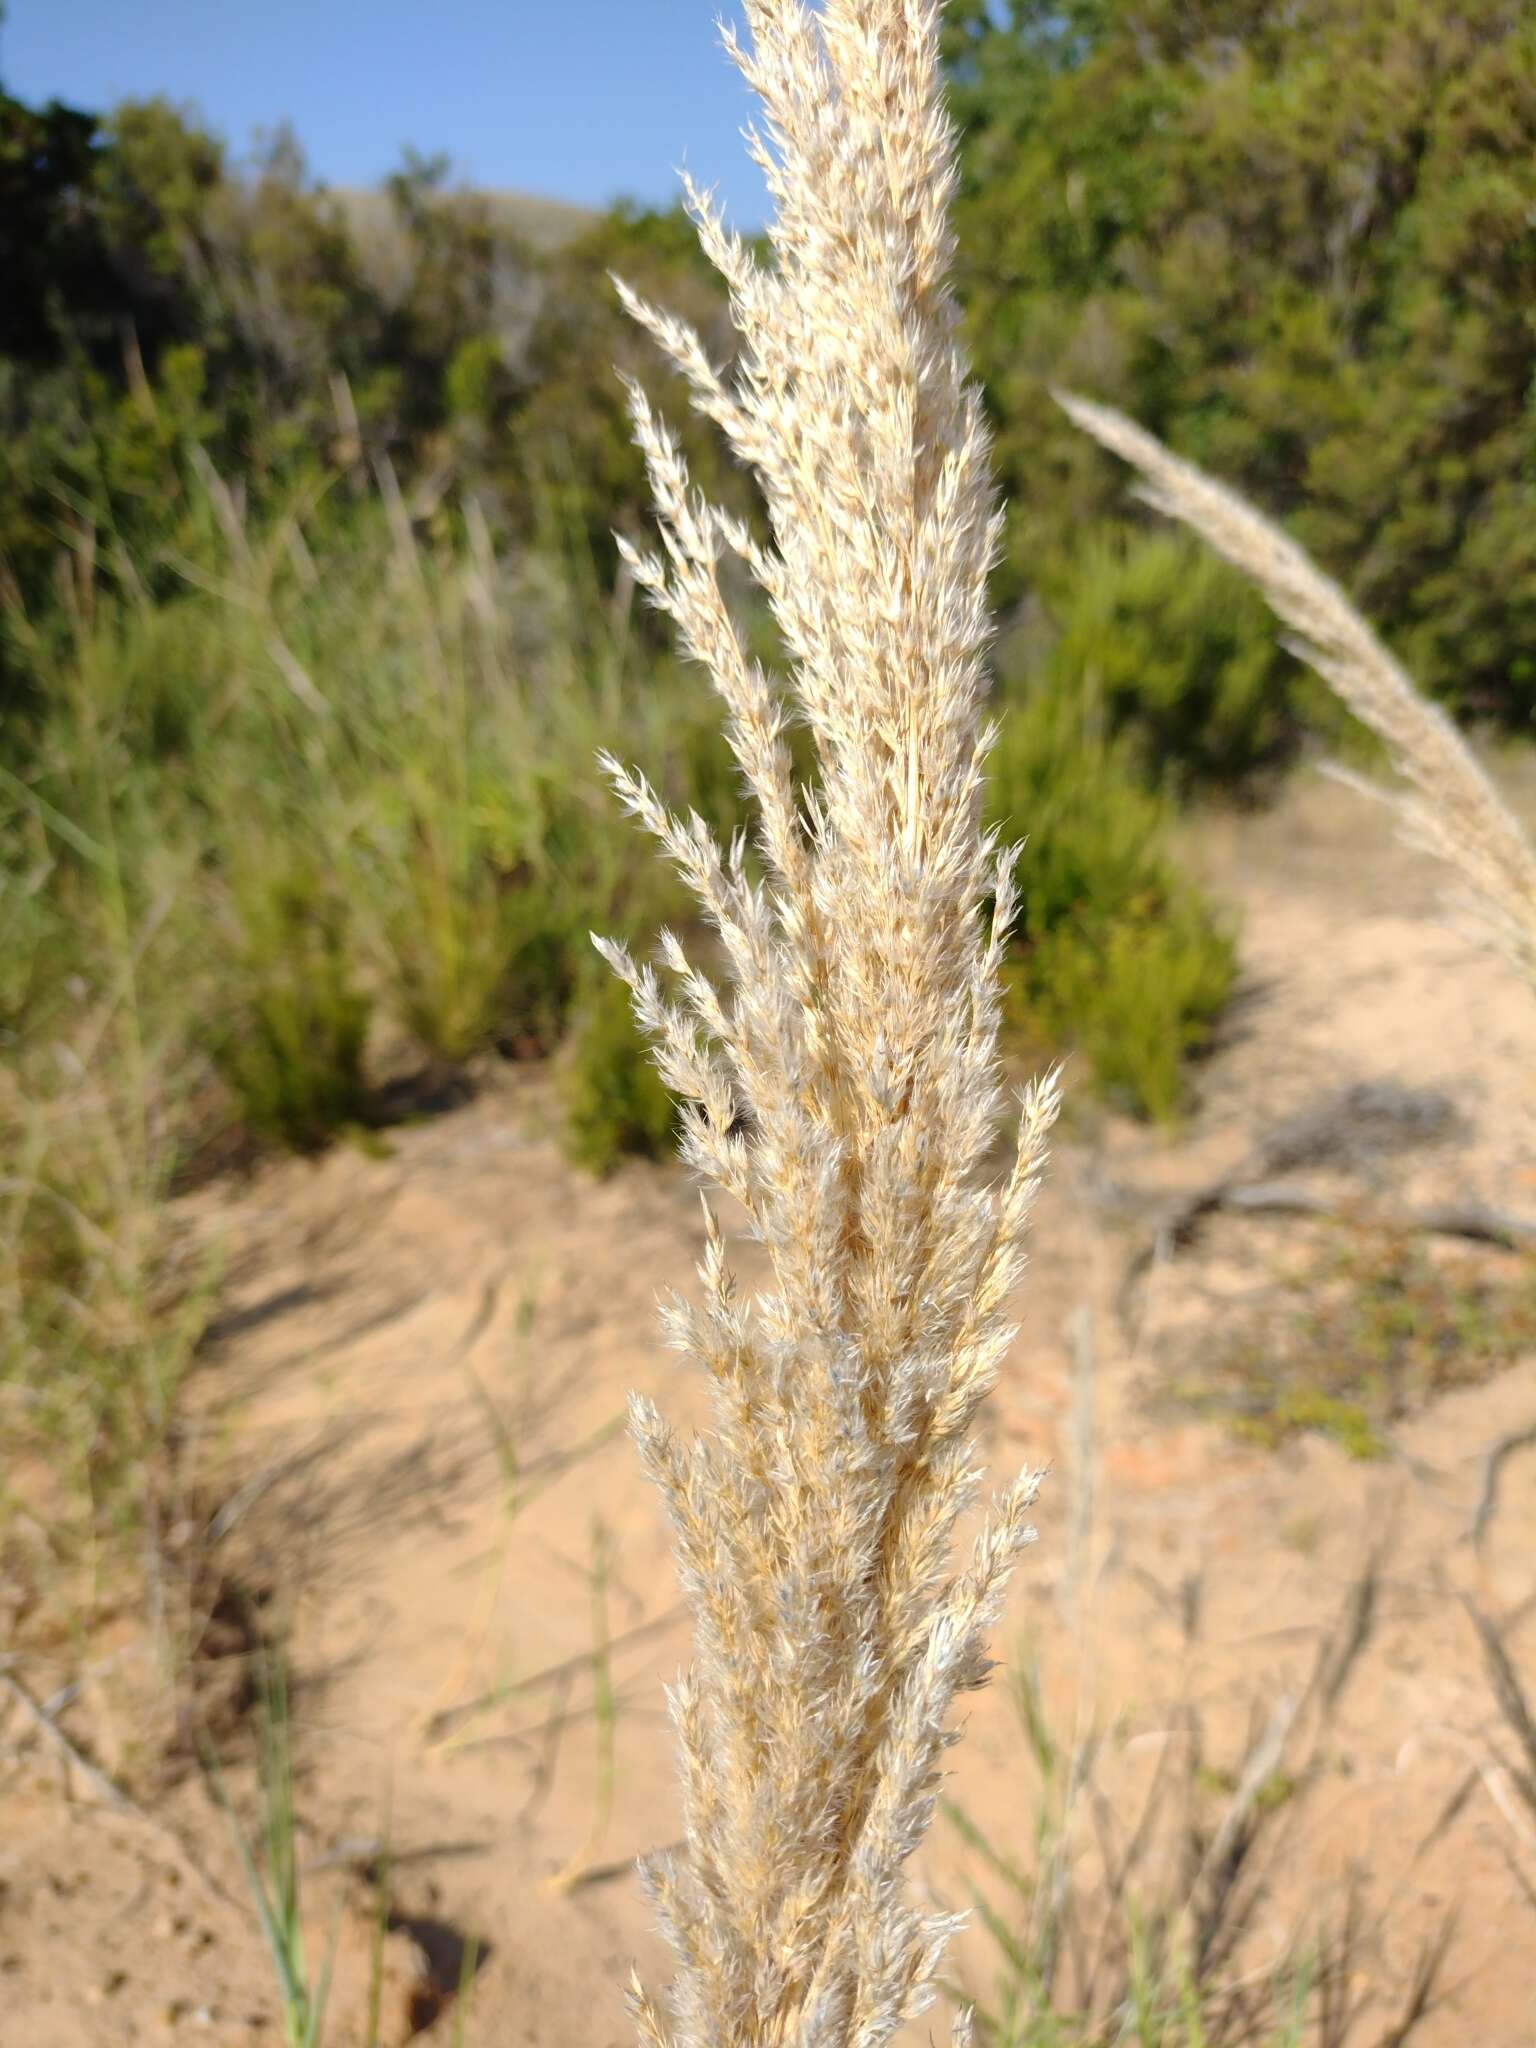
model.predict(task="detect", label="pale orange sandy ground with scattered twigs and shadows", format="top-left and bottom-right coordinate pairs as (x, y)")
top-left (0, 784), bottom-right (1536, 2048)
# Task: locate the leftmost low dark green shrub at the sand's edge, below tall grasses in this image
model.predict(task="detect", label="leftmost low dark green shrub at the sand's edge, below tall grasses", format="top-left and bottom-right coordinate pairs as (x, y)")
top-left (209, 852), bottom-right (373, 1153)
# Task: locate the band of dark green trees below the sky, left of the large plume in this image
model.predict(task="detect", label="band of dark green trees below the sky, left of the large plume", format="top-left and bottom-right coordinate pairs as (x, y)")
top-left (0, 74), bottom-right (745, 630)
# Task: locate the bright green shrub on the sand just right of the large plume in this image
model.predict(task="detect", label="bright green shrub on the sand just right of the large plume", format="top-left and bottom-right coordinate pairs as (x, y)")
top-left (989, 692), bottom-right (1235, 1120)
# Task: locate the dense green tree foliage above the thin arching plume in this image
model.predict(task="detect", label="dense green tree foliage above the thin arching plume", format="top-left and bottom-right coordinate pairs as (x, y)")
top-left (948, 0), bottom-right (1536, 727)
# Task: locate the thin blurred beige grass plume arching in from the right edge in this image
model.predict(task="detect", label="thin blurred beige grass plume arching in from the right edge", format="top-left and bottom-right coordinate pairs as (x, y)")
top-left (1057, 391), bottom-right (1536, 985)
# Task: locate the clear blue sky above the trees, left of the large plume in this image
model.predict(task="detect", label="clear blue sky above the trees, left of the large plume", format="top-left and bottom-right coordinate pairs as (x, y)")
top-left (0, 0), bottom-right (762, 227)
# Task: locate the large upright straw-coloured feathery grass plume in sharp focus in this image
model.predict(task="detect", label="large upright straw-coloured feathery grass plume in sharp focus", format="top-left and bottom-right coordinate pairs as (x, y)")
top-left (602, 0), bottom-right (1057, 2048)
